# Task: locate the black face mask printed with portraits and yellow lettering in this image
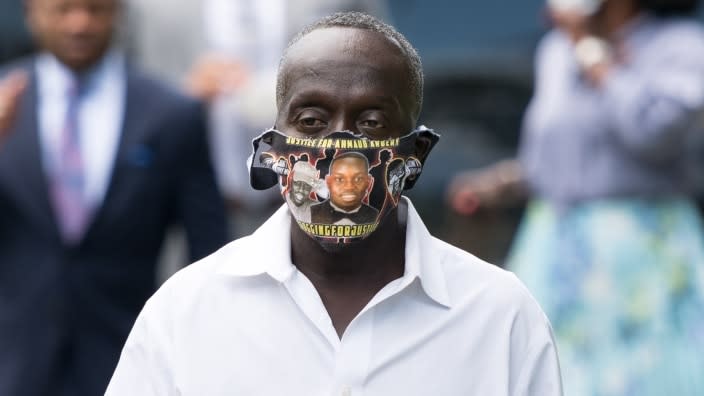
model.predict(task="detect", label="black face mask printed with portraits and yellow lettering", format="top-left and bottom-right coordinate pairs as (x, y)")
top-left (250, 127), bottom-right (439, 243)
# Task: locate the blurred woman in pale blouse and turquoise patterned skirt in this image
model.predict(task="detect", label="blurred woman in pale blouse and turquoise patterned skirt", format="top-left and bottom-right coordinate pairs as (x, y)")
top-left (449, 0), bottom-right (704, 396)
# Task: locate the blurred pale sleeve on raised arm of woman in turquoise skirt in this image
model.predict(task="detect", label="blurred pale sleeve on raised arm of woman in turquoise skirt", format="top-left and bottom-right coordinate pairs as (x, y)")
top-left (604, 22), bottom-right (704, 163)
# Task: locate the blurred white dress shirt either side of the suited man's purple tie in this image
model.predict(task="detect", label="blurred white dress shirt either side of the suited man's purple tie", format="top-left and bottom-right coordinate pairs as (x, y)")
top-left (36, 51), bottom-right (126, 206)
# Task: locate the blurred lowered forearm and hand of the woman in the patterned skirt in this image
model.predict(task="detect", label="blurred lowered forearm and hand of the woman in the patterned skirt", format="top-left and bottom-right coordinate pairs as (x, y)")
top-left (447, 160), bottom-right (526, 215)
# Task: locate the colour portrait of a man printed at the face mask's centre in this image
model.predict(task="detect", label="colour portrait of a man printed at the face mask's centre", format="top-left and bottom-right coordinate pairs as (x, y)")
top-left (310, 152), bottom-right (379, 224)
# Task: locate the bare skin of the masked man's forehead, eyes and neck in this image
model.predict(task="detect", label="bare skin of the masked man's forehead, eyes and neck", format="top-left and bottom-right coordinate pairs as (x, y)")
top-left (277, 27), bottom-right (428, 337)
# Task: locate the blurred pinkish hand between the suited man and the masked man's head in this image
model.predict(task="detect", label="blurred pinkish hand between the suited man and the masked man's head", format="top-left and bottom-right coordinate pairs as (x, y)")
top-left (186, 54), bottom-right (249, 101)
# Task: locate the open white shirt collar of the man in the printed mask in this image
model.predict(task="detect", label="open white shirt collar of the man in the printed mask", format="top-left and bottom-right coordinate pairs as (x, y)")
top-left (217, 197), bottom-right (451, 307)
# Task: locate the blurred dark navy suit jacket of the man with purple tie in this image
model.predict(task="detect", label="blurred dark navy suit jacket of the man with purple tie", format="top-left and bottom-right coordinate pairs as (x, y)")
top-left (0, 58), bottom-right (226, 396)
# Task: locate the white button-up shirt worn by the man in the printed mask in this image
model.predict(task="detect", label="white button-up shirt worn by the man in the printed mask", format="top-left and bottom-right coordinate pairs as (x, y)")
top-left (106, 200), bottom-right (562, 396)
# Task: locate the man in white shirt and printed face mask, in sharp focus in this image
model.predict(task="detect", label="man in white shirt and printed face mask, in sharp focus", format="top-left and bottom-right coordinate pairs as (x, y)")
top-left (107, 13), bottom-right (561, 396)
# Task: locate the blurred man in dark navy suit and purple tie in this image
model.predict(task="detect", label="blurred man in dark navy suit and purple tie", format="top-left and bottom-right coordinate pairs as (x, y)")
top-left (0, 0), bottom-right (226, 396)
